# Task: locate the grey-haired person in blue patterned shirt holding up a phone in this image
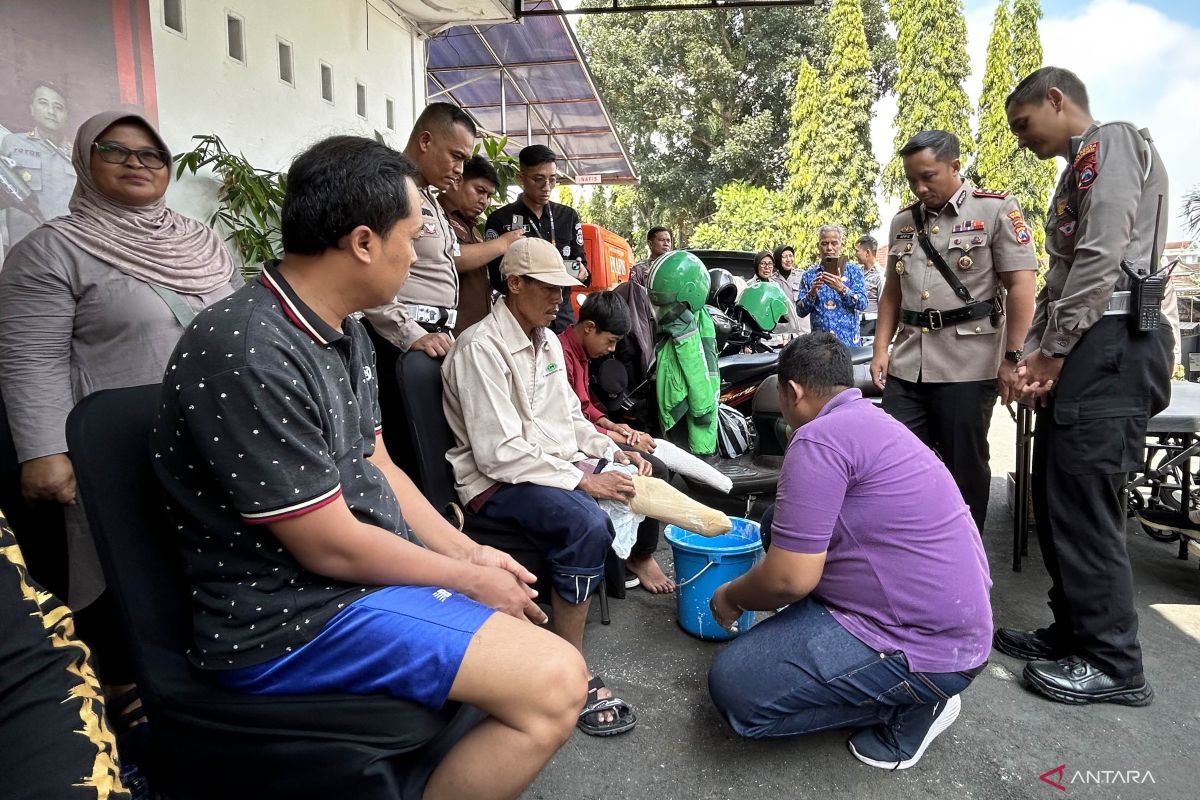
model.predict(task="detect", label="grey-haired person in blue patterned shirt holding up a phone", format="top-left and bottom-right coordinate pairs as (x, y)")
top-left (796, 225), bottom-right (866, 347)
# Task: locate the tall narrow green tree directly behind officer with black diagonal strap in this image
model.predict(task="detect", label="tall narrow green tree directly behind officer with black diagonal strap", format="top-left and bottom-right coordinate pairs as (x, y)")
top-left (883, 0), bottom-right (973, 197)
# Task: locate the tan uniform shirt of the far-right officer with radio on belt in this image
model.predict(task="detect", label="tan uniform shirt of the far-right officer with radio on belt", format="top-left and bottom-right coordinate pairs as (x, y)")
top-left (1025, 122), bottom-right (1170, 355)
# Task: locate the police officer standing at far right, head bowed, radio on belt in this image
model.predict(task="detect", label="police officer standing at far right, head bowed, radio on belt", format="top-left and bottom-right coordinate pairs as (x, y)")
top-left (994, 67), bottom-right (1172, 705)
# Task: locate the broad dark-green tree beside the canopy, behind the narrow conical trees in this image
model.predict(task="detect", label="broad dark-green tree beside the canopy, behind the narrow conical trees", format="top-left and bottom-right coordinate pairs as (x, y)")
top-left (578, 0), bottom-right (895, 237)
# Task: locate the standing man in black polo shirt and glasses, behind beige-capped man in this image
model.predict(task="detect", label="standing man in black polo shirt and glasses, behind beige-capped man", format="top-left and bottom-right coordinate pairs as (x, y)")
top-left (484, 144), bottom-right (589, 333)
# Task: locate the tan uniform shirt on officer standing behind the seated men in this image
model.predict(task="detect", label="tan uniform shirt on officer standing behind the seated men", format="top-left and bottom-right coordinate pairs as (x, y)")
top-left (365, 186), bottom-right (458, 353)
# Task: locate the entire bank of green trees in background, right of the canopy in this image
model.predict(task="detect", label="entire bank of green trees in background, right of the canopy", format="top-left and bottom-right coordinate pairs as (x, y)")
top-left (578, 0), bottom-right (1055, 254)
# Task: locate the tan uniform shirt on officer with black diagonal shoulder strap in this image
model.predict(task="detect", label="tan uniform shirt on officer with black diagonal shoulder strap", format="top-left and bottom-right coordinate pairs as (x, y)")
top-left (888, 181), bottom-right (1038, 384)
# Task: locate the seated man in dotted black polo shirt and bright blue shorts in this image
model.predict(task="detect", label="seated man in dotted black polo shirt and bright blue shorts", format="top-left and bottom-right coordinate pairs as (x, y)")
top-left (152, 137), bottom-right (587, 798)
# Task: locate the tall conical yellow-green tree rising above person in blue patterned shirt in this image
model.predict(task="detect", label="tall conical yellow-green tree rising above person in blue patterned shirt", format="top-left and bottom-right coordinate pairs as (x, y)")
top-left (792, 0), bottom-right (880, 243)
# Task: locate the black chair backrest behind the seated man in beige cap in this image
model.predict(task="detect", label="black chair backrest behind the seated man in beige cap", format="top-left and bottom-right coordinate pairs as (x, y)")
top-left (396, 350), bottom-right (458, 512)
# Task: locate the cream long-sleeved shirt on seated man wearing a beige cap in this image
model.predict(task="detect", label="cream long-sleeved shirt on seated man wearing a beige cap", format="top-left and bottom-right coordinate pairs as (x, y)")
top-left (442, 297), bottom-right (618, 504)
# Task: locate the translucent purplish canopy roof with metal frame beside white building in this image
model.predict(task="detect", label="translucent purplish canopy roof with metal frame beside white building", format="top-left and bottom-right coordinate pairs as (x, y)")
top-left (425, 0), bottom-right (638, 184)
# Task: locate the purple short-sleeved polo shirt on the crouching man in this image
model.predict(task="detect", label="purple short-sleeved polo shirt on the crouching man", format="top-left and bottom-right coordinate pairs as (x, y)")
top-left (772, 389), bottom-right (991, 672)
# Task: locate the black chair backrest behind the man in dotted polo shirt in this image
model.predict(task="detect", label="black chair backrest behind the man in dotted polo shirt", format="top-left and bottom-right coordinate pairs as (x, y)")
top-left (67, 384), bottom-right (196, 711)
